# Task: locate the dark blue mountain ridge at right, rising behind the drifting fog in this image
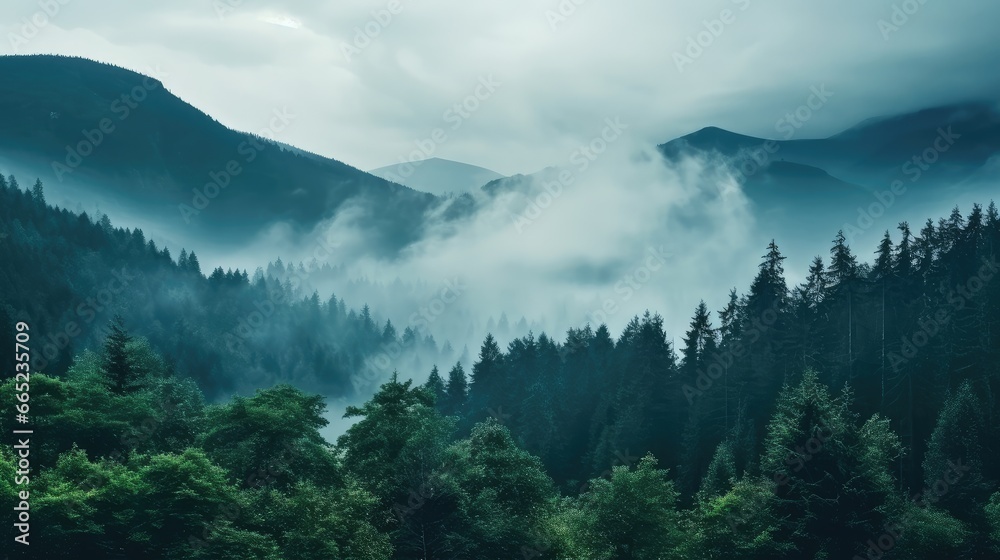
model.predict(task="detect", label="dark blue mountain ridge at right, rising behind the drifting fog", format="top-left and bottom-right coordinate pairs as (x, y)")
top-left (658, 102), bottom-right (1000, 254)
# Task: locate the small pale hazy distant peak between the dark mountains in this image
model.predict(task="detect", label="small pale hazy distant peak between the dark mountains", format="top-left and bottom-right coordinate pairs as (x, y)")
top-left (369, 158), bottom-right (503, 196)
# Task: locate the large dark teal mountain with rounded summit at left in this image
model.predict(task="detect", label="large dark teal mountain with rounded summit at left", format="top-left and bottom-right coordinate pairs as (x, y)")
top-left (0, 55), bottom-right (438, 253)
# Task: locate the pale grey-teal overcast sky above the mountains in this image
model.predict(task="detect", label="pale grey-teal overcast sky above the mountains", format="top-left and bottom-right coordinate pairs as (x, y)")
top-left (0, 0), bottom-right (1000, 174)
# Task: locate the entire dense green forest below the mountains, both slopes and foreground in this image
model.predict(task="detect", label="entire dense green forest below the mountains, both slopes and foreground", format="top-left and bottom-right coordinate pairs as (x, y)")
top-left (0, 174), bottom-right (1000, 560)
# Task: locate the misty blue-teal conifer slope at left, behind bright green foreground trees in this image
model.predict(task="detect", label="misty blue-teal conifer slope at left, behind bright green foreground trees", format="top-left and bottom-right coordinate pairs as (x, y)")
top-left (0, 176), bottom-right (450, 399)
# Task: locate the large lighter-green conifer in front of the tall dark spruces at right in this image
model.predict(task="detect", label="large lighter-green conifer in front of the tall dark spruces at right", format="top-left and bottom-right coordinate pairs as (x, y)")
top-left (761, 371), bottom-right (902, 558)
